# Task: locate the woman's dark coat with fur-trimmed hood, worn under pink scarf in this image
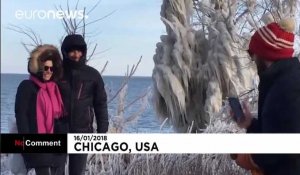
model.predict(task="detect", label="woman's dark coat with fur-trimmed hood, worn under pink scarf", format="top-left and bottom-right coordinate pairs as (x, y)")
top-left (15, 45), bottom-right (66, 169)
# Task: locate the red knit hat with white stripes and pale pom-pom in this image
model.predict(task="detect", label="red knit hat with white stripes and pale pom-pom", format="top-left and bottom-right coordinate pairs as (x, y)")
top-left (249, 18), bottom-right (295, 61)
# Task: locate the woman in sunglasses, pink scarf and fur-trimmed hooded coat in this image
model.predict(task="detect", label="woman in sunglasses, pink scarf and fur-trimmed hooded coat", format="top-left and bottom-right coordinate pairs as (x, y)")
top-left (15, 45), bottom-right (66, 175)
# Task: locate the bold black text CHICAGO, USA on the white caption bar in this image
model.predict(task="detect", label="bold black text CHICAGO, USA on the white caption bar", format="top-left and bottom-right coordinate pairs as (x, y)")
top-left (74, 142), bottom-right (159, 153)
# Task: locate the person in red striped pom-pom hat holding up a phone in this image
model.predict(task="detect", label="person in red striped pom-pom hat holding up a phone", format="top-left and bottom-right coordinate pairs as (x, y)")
top-left (232, 19), bottom-right (300, 175)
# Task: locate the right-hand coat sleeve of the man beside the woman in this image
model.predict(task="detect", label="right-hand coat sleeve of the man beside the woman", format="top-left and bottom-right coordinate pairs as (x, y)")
top-left (93, 72), bottom-right (109, 133)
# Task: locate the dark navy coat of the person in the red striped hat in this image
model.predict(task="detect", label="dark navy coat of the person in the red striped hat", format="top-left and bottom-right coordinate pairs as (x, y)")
top-left (247, 58), bottom-right (300, 175)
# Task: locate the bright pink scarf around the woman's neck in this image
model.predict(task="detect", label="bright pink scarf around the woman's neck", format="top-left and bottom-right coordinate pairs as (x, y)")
top-left (30, 76), bottom-right (63, 134)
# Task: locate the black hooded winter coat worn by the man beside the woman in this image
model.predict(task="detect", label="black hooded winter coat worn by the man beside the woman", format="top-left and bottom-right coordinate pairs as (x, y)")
top-left (59, 35), bottom-right (108, 133)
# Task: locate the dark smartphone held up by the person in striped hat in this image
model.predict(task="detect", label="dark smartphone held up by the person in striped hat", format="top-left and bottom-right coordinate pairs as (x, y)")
top-left (228, 97), bottom-right (245, 121)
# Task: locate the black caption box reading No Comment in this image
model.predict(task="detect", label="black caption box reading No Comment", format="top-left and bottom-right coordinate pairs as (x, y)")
top-left (0, 134), bottom-right (67, 153)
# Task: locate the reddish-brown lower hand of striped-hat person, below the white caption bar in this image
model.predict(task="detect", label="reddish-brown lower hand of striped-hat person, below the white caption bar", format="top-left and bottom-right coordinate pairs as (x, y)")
top-left (230, 154), bottom-right (263, 175)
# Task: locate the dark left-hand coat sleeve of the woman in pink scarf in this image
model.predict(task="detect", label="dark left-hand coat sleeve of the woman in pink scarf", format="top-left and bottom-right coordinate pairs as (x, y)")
top-left (15, 80), bottom-right (32, 134)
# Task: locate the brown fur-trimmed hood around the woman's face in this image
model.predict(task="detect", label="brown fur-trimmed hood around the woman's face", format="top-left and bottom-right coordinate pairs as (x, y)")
top-left (28, 44), bottom-right (62, 81)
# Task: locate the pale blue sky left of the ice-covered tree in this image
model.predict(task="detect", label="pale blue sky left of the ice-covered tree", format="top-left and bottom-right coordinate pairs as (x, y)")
top-left (1, 0), bottom-right (165, 76)
